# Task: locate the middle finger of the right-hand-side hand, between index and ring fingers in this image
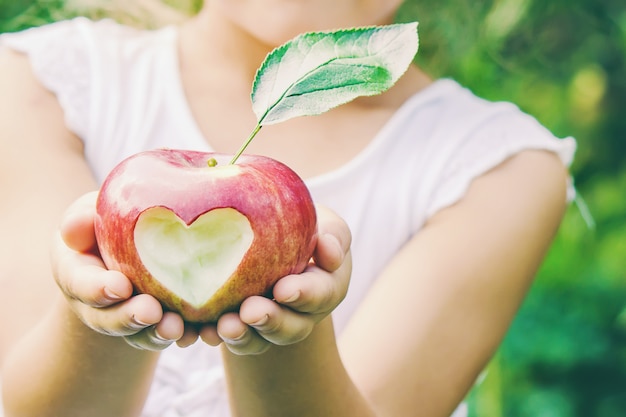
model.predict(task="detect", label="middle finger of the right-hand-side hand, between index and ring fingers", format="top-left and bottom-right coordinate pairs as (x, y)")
top-left (239, 297), bottom-right (314, 345)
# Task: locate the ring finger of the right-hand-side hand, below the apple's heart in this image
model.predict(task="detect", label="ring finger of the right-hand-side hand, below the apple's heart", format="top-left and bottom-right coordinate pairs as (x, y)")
top-left (217, 313), bottom-right (270, 355)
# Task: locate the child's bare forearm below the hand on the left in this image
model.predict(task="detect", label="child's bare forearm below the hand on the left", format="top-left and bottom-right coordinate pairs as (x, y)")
top-left (2, 300), bottom-right (158, 417)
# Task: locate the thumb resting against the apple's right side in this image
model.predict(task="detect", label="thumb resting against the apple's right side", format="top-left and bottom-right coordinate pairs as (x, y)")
top-left (313, 206), bottom-right (352, 272)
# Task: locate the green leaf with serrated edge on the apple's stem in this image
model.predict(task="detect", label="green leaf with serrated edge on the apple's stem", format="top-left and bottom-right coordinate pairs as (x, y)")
top-left (252, 22), bottom-right (419, 126)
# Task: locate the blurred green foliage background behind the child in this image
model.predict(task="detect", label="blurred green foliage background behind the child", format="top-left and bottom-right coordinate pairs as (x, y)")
top-left (0, 0), bottom-right (626, 417)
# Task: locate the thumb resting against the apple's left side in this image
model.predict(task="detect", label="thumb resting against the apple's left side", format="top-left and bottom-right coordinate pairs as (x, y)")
top-left (59, 191), bottom-right (98, 252)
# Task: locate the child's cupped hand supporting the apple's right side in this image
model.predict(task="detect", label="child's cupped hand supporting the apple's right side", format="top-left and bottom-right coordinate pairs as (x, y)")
top-left (200, 207), bottom-right (352, 355)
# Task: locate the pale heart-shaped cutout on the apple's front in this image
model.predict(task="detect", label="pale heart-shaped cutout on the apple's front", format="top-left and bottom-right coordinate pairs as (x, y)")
top-left (134, 207), bottom-right (254, 307)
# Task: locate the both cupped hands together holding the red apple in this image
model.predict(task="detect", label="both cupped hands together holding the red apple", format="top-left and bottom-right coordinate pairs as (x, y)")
top-left (52, 193), bottom-right (351, 354)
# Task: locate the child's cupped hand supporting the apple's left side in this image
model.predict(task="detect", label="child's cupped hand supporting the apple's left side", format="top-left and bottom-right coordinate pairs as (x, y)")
top-left (52, 193), bottom-right (198, 350)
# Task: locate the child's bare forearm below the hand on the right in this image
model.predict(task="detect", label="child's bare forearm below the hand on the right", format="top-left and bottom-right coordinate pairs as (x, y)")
top-left (223, 318), bottom-right (374, 417)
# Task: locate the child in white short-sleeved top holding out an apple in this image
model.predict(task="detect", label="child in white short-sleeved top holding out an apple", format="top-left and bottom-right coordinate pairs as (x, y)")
top-left (0, 0), bottom-right (575, 417)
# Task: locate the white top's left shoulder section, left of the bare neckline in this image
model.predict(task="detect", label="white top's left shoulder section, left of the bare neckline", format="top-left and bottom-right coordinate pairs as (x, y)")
top-left (0, 17), bottom-right (185, 181)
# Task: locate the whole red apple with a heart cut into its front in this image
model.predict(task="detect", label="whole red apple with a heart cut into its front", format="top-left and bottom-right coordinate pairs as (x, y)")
top-left (95, 149), bottom-right (317, 323)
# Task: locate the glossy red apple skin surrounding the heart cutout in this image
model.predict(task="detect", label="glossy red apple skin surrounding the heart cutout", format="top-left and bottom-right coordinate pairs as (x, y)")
top-left (95, 149), bottom-right (317, 323)
